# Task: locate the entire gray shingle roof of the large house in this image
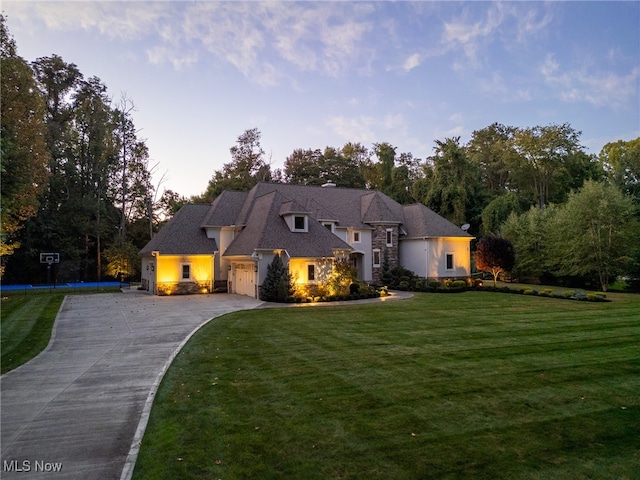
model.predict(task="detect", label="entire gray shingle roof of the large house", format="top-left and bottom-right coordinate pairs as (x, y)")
top-left (141, 183), bottom-right (471, 257)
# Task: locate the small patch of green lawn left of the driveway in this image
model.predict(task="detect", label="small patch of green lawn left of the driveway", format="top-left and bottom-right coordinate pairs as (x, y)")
top-left (0, 294), bottom-right (64, 374)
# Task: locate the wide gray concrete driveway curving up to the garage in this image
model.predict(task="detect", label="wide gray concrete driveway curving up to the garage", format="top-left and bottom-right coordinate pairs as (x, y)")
top-left (0, 291), bottom-right (261, 479)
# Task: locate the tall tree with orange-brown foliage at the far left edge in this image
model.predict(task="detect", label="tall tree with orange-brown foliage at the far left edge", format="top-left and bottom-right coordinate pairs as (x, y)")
top-left (0, 15), bottom-right (49, 276)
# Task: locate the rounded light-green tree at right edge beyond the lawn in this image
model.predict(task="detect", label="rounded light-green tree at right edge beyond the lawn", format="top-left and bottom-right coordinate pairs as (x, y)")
top-left (554, 180), bottom-right (640, 291)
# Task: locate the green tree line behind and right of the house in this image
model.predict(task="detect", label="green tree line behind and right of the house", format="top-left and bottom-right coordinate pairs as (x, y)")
top-left (198, 123), bottom-right (640, 290)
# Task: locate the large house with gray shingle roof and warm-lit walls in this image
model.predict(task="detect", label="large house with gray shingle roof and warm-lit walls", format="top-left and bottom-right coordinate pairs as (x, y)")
top-left (141, 183), bottom-right (473, 297)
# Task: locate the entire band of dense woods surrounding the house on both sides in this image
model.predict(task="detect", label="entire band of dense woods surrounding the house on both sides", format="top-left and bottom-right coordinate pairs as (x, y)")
top-left (0, 17), bottom-right (640, 289)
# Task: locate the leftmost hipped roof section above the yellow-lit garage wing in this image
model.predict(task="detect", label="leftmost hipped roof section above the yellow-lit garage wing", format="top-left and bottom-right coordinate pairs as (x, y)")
top-left (140, 204), bottom-right (218, 255)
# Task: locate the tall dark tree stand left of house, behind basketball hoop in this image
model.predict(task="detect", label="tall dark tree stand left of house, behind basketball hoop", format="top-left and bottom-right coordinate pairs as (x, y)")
top-left (0, 16), bottom-right (175, 283)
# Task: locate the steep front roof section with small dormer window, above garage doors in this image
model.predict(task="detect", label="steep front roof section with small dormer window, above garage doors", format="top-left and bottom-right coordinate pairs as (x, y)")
top-left (223, 191), bottom-right (352, 258)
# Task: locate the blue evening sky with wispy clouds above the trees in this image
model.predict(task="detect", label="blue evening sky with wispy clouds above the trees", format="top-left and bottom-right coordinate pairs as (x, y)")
top-left (1, 0), bottom-right (640, 197)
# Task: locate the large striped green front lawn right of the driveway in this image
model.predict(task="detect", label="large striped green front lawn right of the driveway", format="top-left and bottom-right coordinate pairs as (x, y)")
top-left (134, 292), bottom-right (640, 480)
